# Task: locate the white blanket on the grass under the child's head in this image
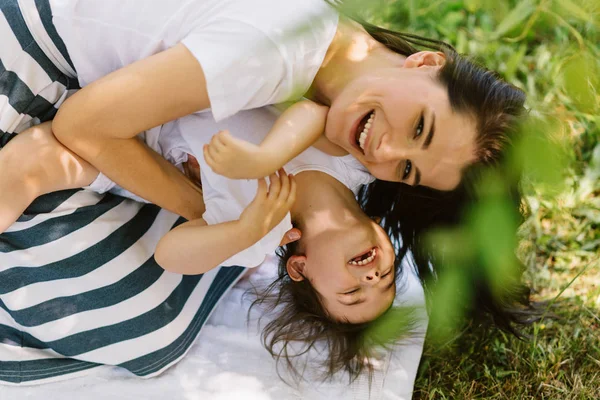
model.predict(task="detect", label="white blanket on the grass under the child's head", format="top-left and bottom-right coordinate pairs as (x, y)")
top-left (0, 258), bottom-right (427, 400)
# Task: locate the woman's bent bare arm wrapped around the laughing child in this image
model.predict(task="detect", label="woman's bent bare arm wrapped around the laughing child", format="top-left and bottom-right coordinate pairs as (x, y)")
top-left (52, 44), bottom-right (210, 219)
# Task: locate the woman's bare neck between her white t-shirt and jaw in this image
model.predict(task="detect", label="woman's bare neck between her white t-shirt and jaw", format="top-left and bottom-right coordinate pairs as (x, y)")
top-left (307, 16), bottom-right (406, 105)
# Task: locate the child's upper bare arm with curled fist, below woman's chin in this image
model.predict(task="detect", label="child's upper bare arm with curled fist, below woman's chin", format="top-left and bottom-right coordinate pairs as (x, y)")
top-left (204, 100), bottom-right (344, 179)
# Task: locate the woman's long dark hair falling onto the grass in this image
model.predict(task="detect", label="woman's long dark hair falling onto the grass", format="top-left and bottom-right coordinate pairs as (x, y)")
top-left (358, 13), bottom-right (536, 335)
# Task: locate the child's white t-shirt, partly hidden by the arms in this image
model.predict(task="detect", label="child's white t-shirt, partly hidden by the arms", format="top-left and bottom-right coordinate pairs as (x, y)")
top-left (176, 107), bottom-right (374, 267)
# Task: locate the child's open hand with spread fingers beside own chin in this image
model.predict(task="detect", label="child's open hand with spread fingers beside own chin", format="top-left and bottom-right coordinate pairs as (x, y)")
top-left (239, 168), bottom-right (296, 241)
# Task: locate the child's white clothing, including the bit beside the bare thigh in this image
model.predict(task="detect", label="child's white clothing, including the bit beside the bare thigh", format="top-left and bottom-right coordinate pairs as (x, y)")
top-left (88, 107), bottom-right (374, 267)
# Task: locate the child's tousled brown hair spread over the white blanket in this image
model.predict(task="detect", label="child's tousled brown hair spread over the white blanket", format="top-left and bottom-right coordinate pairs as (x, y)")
top-left (252, 241), bottom-right (416, 381)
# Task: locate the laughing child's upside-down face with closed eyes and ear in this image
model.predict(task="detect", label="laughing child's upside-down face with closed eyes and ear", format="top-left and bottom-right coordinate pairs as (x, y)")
top-left (287, 213), bottom-right (396, 323)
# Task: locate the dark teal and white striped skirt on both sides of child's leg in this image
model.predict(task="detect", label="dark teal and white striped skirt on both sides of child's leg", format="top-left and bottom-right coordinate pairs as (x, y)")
top-left (0, 0), bottom-right (244, 384)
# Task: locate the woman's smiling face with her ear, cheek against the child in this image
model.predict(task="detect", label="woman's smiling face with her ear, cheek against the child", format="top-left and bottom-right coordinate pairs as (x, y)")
top-left (325, 52), bottom-right (476, 190)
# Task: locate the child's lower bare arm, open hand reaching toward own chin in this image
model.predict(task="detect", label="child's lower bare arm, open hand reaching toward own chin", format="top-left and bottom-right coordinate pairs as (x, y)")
top-left (154, 170), bottom-right (296, 275)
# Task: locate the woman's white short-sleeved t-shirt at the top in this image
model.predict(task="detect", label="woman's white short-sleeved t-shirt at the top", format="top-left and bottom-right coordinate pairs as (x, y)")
top-left (50, 0), bottom-right (338, 121)
